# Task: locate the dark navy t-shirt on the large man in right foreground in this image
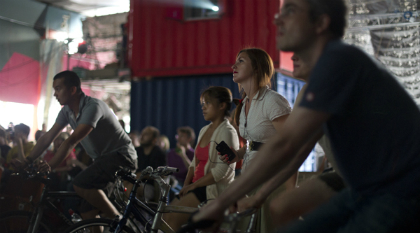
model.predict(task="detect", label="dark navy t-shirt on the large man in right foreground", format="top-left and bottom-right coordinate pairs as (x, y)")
top-left (300, 40), bottom-right (420, 197)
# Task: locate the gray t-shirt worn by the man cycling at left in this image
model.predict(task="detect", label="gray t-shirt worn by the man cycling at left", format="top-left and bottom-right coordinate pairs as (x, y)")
top-left (56, 93), bottom-right (137, 161)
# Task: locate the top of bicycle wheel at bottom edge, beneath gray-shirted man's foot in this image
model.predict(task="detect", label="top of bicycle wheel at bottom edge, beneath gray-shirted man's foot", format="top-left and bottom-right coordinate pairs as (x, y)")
top-left (65, 218), bottom-right (136, 233)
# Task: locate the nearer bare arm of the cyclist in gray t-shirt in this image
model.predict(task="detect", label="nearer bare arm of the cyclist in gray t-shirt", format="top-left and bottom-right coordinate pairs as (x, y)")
top-left (49, 124), bottom-right (93, 169)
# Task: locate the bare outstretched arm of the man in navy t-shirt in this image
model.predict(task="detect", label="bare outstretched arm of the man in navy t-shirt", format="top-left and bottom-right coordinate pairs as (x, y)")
top-left (194, 107), bottom-right (330, 220)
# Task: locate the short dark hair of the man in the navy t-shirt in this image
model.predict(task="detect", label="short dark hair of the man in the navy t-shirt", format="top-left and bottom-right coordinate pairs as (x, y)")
top-left (306, 0), bottom-right (348, 38)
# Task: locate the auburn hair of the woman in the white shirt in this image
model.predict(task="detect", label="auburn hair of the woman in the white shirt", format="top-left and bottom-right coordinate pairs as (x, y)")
top-left (233, 48), bottom-right (274, 126)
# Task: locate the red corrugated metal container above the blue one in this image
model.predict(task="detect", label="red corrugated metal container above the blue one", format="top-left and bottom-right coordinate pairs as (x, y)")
top-left (129, 0), bottom-right (279, 77)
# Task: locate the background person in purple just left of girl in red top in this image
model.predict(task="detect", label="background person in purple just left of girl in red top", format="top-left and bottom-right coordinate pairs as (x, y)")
top-left (167, 126), bottom-right (195, 201)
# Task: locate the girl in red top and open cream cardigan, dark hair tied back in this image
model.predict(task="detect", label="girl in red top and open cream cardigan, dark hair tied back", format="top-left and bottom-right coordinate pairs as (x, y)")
top-left (163, 87), bottom-right (239, 231)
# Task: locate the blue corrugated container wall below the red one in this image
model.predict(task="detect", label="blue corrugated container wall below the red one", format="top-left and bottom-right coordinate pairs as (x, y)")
top-left (130, 74), bottom-right (243, 146)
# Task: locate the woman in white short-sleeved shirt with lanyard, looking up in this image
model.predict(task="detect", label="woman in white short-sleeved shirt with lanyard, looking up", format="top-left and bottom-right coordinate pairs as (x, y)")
top-left (220, 48), bottom-right (297, 232)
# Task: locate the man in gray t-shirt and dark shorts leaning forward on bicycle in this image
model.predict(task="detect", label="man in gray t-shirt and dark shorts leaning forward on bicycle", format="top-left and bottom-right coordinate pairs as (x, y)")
top-left (13, 71), bottom-right (137, 219)
